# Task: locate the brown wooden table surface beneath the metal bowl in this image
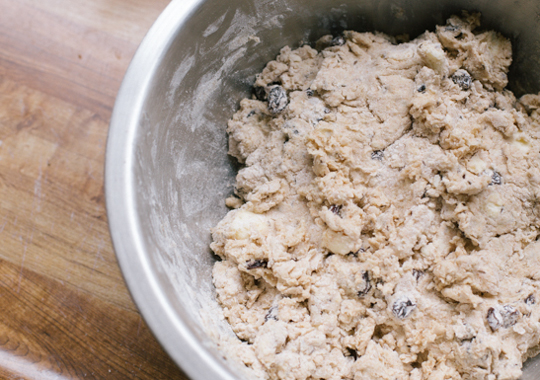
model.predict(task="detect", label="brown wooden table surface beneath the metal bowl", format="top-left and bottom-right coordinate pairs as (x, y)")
top-left (0, 0), bottom-right (190, 380)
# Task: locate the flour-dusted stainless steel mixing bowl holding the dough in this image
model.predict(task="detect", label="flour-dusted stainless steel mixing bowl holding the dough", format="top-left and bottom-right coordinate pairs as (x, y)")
top-left (106, 0), bottom-right (540, 380)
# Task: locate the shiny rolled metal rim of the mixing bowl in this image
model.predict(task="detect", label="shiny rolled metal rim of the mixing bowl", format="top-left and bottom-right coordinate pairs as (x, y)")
top-left (105, 0), bottom-right (236, 380)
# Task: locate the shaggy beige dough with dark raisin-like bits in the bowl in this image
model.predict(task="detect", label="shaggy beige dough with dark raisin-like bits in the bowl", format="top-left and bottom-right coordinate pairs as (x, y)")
top-left (211, 13), bottom-right (540, 380)
